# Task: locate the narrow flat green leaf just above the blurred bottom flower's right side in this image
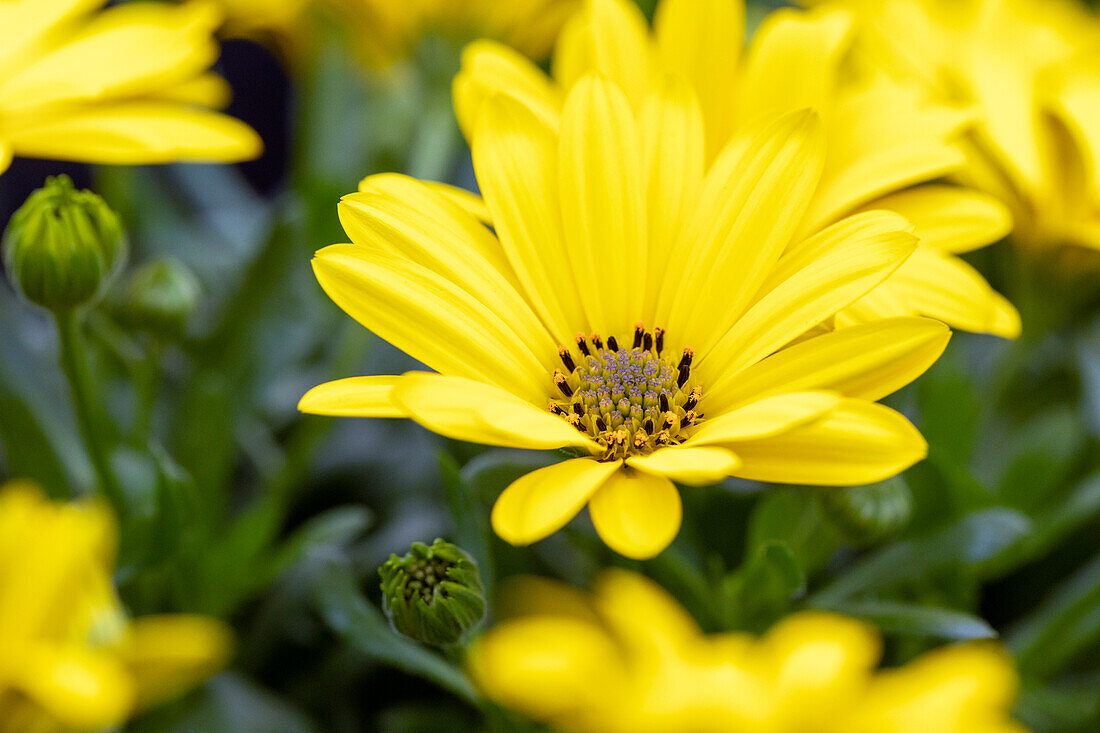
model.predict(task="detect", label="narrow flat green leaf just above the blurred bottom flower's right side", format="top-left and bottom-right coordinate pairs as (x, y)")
top-left (811, 601), bottom-right (997, 642)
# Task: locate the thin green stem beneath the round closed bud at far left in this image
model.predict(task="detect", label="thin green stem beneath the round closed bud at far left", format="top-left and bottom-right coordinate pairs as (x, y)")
top-left (54, 310), bottom-right (128, 517)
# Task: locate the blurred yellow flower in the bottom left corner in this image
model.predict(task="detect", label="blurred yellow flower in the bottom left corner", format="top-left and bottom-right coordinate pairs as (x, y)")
top-left (0, 482), bottom-right (232, 733)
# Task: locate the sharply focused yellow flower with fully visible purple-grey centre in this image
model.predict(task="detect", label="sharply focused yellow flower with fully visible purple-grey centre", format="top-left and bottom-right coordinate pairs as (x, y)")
top-left (300, 71), bottom-right (948, 557)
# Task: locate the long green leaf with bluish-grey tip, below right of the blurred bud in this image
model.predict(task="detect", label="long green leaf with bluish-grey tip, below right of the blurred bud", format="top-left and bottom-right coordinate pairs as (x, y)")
top-left (813, 508), bottom-right (1031, 604)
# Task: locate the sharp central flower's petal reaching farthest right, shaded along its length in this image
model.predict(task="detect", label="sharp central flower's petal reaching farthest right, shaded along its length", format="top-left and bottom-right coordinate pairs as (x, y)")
top-left (704, 317), bottom-right (950, 413)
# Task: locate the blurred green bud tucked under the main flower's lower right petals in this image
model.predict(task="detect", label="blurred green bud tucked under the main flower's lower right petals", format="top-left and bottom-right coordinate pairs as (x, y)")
top-left (824, 477), bottom-right (913, 545)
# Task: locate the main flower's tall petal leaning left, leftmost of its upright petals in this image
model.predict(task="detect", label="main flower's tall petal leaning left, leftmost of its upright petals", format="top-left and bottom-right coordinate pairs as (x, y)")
top-left (471, 97), bottom-right (586, 343)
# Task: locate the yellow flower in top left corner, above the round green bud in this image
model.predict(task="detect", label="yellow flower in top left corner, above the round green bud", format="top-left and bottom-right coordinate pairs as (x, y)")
top-left (0, 0), bottom-right (261, 177)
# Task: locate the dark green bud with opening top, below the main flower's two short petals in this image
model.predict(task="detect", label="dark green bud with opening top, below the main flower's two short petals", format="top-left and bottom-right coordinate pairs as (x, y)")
top-left (378, 539), bottom-right (485, 646)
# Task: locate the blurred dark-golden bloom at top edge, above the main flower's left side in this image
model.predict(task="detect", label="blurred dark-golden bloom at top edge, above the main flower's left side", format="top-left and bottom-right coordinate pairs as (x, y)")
top-left (329, 0), bottom-right (580, 67)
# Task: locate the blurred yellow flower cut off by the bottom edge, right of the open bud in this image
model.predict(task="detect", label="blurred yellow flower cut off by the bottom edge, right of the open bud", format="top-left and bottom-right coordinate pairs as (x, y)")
top-left (469, 570), bottom-right (1025, 733)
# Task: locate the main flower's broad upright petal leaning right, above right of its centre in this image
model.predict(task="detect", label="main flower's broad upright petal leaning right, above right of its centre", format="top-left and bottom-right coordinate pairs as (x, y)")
top-left (658, 111), bottom-right (824, 353)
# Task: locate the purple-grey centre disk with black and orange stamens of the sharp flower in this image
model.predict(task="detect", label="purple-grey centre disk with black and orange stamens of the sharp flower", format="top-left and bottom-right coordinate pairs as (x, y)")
top-left (549, 324), bottom-right (703, 460)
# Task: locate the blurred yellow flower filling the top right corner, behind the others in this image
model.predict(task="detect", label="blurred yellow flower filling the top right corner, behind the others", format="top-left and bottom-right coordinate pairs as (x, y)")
top-left (809, 0), bottom-right (1100, 254)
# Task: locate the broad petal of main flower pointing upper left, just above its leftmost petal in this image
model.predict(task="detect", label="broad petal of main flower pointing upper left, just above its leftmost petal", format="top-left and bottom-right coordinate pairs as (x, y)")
top-left (314, 244), bottom-right (550, 403)
